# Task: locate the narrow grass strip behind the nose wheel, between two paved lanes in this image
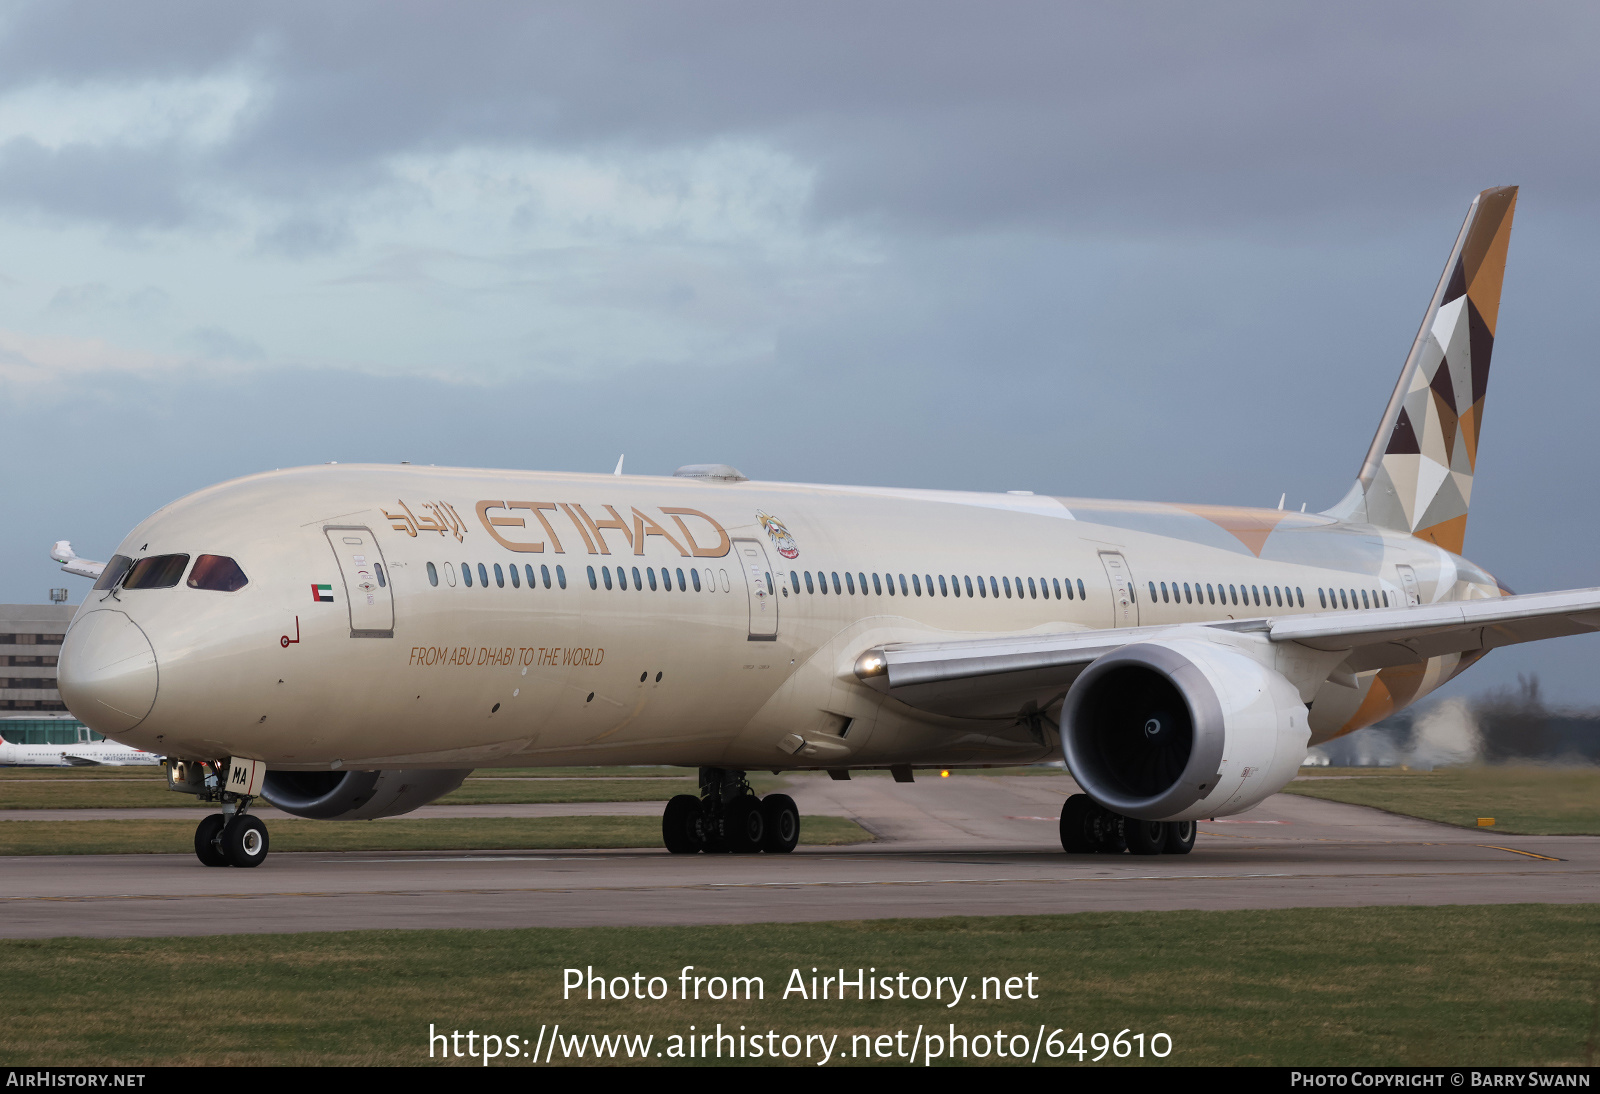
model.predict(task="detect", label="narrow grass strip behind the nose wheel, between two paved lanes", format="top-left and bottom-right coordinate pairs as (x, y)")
top-left (0, 817), bottom-right (872, 856)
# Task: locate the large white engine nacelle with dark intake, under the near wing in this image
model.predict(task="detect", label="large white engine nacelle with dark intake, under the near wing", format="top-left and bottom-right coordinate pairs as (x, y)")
top-left (1061, 638), bottom-right (1310, 821)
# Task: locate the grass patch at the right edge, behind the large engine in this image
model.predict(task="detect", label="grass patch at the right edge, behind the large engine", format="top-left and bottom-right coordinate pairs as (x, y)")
top-left (1285, 765), bottom-right (1600, 835)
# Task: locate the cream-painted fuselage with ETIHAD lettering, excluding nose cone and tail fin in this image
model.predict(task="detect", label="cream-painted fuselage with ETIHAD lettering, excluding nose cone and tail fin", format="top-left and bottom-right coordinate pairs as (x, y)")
top-left (62, 465), bottom-right (1501, 769)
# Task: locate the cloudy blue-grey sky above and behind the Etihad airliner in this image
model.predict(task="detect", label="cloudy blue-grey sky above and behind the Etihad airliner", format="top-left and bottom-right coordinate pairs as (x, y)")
top-left (0, 0), bottom-right (1600, 702)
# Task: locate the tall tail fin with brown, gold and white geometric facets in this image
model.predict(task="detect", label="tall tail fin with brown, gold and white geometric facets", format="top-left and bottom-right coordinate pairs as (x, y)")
top-left (1328, 186), bottom-right (1517, 553)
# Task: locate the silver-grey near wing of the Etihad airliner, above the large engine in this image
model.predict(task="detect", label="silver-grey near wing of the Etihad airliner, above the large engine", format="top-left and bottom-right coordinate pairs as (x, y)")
top-left (856, 589), bottom-right (1600, 718)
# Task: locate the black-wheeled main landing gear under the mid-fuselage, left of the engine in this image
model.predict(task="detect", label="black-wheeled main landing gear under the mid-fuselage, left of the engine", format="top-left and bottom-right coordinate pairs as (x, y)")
top-left (661, 768), bottom-right (800, 854)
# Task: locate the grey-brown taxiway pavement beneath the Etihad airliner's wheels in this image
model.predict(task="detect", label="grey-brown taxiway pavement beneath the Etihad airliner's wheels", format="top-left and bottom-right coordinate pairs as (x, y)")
top-left (0, 776), bottom-right (1600, 937)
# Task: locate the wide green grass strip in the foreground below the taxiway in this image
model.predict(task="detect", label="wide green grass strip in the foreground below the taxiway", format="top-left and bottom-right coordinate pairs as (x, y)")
top-left (0, 905), bottom-right (1600, 1067)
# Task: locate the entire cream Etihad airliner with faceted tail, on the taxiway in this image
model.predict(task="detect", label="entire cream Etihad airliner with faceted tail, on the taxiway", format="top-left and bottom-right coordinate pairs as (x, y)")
top-left (50, 187), bottom-right (1600, 865)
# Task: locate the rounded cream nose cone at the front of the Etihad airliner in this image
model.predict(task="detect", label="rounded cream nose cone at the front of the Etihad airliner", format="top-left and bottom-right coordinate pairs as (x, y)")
top-left (56, 608), bottom-right (157, 734)
